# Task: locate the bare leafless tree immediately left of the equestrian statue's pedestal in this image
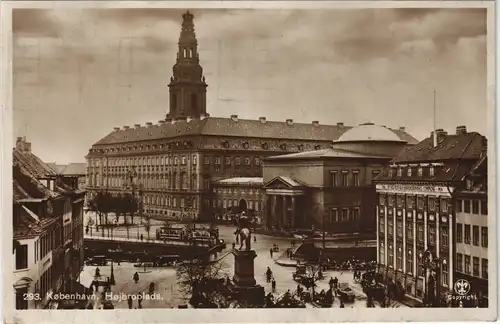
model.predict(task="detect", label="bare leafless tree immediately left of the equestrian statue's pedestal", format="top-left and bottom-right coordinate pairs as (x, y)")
top-left (177, 260), bottom-right (230, 308)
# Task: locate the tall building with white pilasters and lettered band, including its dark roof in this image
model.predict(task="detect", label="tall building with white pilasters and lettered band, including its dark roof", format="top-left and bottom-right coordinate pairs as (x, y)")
top-left (375, 126), bottom-right (486, 305)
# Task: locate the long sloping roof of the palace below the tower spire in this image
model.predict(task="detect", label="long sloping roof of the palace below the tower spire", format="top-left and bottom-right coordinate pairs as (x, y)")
top-left (94, 117), bottom-right (417, 145)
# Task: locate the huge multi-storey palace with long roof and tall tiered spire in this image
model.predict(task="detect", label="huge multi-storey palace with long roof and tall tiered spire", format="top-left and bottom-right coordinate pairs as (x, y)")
top-left (86, 12), bottom-right (415, 219)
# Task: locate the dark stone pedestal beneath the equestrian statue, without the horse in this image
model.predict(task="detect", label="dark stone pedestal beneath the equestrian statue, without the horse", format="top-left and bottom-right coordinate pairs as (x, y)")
top-left (227, 250), bottom-right (265, 304)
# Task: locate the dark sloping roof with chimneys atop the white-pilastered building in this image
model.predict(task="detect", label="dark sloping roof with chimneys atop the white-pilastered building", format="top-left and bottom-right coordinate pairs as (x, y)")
top-left (393, 132), bottom-right (487, 163)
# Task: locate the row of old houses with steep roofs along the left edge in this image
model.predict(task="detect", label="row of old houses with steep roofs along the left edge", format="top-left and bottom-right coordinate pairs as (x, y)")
top-left (12, 138), bottom-right (85, 309)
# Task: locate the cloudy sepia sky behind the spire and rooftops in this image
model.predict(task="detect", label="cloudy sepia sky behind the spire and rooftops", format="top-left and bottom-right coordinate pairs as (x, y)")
top-left (13, 9), bottom-right (486, 163)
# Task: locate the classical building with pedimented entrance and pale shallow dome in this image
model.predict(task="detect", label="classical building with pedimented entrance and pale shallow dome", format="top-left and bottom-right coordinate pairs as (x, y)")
top-left (263, 123), bottom-right (413, 242)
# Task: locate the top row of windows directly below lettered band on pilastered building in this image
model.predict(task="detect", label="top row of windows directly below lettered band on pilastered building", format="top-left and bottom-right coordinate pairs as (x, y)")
top-left (379, 194), bottom-right (451, 213)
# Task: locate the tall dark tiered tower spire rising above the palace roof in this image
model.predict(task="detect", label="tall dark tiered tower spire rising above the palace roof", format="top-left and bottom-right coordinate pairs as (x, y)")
top-left (167, 10), bottom-right (207, 118)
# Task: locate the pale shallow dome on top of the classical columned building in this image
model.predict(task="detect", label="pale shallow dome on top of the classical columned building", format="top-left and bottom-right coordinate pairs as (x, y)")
top-left (335, 123), bottom-right (404, 142)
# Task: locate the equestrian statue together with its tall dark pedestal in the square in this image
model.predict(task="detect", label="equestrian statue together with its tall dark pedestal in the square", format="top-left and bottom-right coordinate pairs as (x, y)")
top-left (228, 214), bottom-right (265, 304)
